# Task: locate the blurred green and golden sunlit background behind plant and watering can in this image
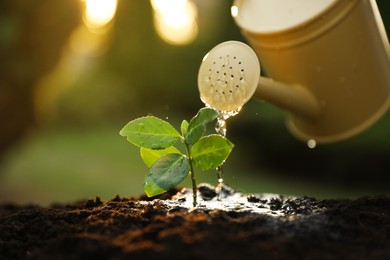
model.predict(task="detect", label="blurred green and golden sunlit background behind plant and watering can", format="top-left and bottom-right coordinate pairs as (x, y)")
top-left (0, 0), bottom-right (390, 205)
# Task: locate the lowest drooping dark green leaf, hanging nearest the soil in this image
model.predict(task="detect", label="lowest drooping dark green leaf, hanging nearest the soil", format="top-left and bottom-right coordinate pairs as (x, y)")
top-left (144, 153), bottom-right (190, 197)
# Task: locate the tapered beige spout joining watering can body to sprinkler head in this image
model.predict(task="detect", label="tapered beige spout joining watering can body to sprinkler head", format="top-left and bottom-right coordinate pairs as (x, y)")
top-left (254, 77), bottom-right (320, 120)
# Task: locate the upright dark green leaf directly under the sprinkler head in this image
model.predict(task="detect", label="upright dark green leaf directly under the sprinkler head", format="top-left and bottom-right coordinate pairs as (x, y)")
top-left (185, 107), bottom-right (218, 145)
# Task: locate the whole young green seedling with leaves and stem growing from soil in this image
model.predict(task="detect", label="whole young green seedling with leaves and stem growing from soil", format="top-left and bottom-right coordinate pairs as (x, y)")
top-left (120, 108), bottom-right (234, 207)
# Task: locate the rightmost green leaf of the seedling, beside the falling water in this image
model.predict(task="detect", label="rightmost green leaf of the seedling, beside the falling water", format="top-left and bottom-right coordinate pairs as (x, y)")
top-left (191, 135), bottom-right (234, 171)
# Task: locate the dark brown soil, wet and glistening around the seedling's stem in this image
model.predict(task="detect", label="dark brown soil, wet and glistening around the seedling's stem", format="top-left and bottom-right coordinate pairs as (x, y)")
top-left (0, 184), bottom-right (390, 259)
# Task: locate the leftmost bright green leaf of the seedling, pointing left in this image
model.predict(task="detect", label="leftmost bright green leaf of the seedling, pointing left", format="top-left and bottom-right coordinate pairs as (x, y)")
top-left (119, 116), bottom-right (180, 150)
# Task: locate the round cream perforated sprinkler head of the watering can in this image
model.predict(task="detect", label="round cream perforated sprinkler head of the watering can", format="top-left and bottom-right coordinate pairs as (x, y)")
top-left (198, 41), bottom-right (260, 113)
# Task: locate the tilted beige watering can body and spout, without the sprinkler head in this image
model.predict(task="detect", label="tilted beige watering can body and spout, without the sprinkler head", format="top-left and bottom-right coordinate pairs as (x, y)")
top-left (232, 0), bottom-right (390, 143)
